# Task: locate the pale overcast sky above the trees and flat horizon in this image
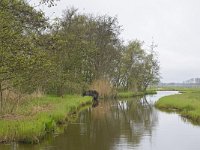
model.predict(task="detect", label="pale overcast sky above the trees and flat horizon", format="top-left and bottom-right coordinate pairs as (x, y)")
top-left (31, 0), bottom-right (200, 82)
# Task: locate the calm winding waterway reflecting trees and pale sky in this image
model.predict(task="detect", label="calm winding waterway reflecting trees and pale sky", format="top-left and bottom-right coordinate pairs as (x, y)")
top-left (0, 92), bottom-right (200, 150)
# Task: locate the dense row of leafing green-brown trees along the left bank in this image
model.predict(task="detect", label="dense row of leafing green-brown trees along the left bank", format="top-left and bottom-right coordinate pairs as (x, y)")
top-left (0, 0), bottom-right (159, 105)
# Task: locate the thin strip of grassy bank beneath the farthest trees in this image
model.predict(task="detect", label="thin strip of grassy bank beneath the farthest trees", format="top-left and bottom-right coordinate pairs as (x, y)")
top-left (117, 90), bottom-right (156, 98)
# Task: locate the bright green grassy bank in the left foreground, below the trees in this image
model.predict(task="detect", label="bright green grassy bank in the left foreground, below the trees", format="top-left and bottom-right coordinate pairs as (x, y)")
top-left (0, 95), bottom-right (91, 143)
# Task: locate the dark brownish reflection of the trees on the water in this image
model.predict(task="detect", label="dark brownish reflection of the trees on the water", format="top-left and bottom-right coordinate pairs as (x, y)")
top-left (47, 98), bottom-right (157, 150)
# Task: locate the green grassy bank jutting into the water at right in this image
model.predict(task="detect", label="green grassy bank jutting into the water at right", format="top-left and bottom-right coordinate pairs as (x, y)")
top-left (155, 89), bottom-right (200, 123)
